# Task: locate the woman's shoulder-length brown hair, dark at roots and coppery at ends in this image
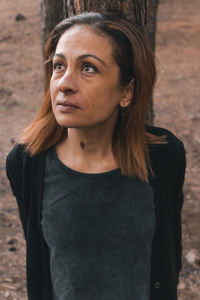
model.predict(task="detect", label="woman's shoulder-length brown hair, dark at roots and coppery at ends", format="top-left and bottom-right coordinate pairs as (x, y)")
top-left (20, 11), bottom-right (165, 181)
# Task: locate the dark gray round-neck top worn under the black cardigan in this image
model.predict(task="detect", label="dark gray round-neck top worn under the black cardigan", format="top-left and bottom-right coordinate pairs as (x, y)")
top-left (41, 148), bottom-right (155, 300)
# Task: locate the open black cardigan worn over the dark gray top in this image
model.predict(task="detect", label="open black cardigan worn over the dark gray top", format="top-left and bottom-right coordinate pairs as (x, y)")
top-left (6, 126), bottom-right (185, 300)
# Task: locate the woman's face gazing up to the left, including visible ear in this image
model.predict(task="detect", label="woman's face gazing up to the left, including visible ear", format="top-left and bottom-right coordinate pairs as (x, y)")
top-left (50, 25), bottom-right (130, 128)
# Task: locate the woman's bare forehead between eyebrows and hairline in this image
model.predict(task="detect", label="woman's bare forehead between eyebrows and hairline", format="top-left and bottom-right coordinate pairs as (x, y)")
top-left (56, 25), bottom-right (114, 61)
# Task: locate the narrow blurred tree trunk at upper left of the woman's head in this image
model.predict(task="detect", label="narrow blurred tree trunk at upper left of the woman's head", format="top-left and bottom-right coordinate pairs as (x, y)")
top-left (40, 0), bottom-right (65, 49)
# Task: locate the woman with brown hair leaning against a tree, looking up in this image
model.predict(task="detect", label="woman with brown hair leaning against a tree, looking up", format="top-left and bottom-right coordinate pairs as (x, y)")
top-left (7, 12), bottom-right (185, 300)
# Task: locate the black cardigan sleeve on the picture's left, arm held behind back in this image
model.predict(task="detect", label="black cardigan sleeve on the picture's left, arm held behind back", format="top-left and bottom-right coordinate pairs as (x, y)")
top-left (6, 144), bottom-right (26, 238)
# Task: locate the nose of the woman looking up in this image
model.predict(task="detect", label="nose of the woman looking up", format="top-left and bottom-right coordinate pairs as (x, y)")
top-left (57, 69), bottom-right (77, 94)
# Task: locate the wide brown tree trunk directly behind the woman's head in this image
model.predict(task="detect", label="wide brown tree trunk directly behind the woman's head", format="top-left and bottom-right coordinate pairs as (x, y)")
top-left (63, 0), bottom-right (158, 123)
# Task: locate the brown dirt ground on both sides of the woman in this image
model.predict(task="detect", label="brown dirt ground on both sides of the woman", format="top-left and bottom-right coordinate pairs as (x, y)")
top-left (0, 0), bottom-right (200, 300)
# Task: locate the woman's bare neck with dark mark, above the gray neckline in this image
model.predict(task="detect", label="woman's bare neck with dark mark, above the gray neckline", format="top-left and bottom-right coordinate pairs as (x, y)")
top-left (57, 115), bottom-right (117, 173)
